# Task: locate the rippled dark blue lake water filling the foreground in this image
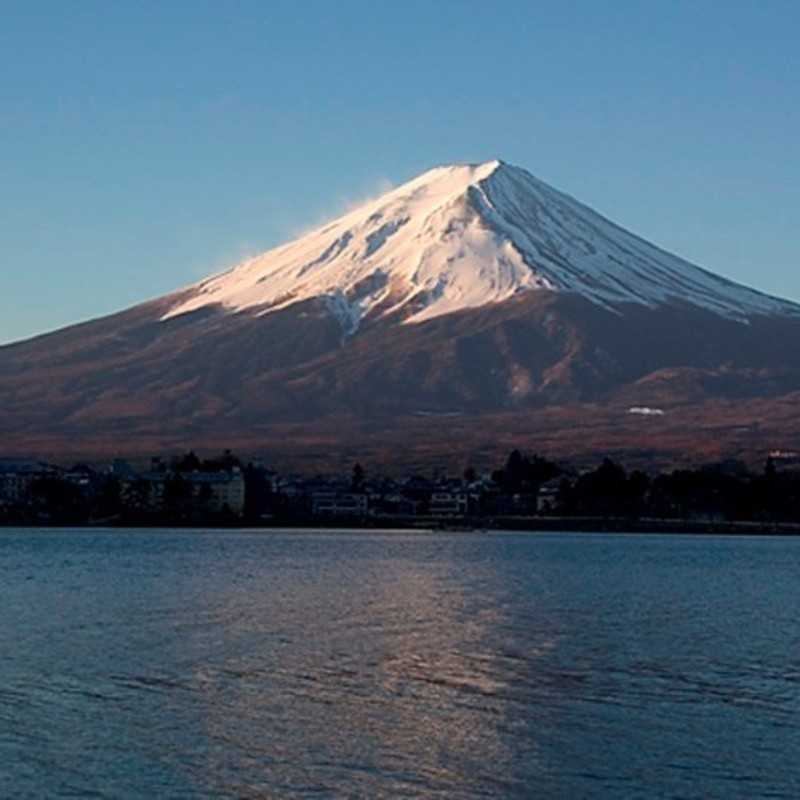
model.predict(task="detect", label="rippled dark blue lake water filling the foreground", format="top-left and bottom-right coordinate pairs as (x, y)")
top-left (0, 531), bottom-right (800, 798)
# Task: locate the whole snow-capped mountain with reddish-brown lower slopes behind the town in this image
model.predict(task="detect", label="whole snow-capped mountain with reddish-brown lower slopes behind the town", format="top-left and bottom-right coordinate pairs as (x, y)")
top-left (0, 161), bottom-right (800, 464)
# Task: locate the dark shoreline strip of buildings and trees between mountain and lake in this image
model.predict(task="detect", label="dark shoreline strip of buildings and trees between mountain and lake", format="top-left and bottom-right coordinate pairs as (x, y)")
top-left (0, 450), bottom-right (800, 532)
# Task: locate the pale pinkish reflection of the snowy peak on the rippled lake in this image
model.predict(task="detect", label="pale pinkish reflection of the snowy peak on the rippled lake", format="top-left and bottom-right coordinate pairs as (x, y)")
top-left (180, 537), bottom-right (554, 796)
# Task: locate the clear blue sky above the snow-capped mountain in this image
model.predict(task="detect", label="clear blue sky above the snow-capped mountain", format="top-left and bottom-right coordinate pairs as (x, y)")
top-left (0, 0), bottom-right (800, 342)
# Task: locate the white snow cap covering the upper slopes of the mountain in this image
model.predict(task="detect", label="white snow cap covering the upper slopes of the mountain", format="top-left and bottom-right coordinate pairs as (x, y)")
top-left (164, 161), bottom-right (800, 334)
